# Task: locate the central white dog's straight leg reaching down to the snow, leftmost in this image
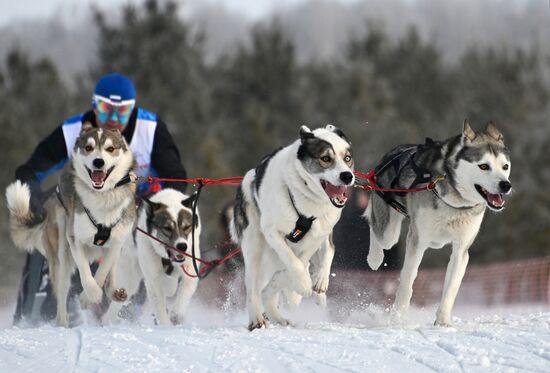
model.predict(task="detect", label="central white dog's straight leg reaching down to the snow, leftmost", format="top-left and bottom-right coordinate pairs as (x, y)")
top-left (241, 227), bottom-right (267, 331)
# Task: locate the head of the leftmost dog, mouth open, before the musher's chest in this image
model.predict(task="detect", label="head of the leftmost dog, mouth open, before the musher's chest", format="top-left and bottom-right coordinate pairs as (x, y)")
top-left (72, 123), bottom-right (132, 191)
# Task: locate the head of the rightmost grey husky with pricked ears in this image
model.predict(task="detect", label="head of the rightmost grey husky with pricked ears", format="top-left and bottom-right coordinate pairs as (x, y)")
top-left (456, 122), bottom-right (512, 211)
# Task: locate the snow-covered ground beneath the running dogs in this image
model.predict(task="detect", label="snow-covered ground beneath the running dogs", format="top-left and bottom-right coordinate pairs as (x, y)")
top-left (0, 299), bottom-right (550, 373)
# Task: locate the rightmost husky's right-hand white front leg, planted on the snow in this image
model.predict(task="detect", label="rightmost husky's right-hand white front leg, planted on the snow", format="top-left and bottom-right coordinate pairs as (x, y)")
top-left (435, 244), bottom-right (470, 326)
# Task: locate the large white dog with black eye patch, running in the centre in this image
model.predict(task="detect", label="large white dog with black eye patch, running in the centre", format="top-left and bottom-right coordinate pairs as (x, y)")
top-left (231, 125), bottom-right (355, 330)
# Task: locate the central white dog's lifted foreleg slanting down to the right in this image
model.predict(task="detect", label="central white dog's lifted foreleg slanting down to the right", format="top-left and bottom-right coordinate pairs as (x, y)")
top-left (266, 229), bottom-right (313, 297)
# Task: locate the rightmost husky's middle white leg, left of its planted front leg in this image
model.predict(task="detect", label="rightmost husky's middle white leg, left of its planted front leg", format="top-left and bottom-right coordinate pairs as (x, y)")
top-left (394, 227), bottom-right (426, 311)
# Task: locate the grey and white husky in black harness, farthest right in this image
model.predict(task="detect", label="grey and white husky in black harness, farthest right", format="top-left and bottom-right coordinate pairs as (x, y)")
top-left (365, 121), bottom-right (512, 325)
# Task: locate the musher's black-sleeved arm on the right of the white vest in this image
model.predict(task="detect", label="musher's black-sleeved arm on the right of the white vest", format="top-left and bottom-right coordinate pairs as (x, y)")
top-left (151, 120), bottom-right (187, 193)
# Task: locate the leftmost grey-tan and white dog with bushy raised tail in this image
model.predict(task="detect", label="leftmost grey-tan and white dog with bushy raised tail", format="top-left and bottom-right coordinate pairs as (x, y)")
top-left (6, 123), bottom-right (136, 326)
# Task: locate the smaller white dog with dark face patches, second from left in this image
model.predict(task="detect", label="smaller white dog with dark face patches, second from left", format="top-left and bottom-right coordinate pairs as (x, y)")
top-left (119, 188), bottom-right (201, 325)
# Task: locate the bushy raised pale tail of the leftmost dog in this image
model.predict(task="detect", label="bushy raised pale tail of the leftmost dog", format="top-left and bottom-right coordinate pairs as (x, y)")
top-left (6, 180), bottom-right (44, 252)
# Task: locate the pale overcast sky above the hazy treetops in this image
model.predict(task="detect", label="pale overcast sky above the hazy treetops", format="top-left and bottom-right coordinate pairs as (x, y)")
top-left (0, 0), bottom-right (357, 26)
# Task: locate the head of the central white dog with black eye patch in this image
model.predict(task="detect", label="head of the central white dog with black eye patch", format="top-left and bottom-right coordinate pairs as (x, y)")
top-left (298, 125), bottom-right (355, 208)
